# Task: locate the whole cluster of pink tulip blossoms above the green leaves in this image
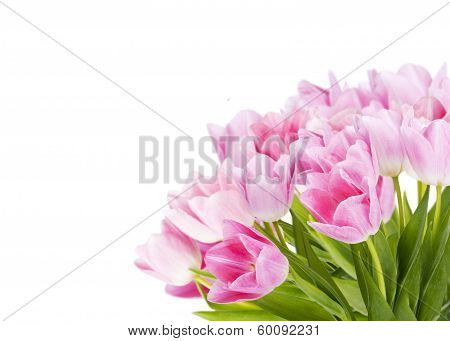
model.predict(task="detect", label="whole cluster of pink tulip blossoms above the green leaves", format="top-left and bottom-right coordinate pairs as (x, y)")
top-left (136, 64), bottom-right (450, 318)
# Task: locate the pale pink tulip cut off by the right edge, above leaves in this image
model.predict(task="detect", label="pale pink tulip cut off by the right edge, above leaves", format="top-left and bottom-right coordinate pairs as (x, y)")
top-left (401, 119), bottom-right (450, 186)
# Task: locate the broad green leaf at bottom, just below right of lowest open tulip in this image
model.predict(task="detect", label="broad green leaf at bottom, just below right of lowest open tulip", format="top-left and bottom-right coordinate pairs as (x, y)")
top-left (253, 282), bottom-right (334, 321)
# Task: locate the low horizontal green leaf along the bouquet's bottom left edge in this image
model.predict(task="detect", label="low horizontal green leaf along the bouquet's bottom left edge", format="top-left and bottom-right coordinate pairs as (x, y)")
top-left (193, 310), bottom-right (284, 321)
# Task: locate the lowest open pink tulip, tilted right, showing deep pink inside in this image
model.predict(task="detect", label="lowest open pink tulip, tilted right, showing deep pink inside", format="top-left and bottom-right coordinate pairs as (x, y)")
top-left (205, 221), bottom-right (289, 303)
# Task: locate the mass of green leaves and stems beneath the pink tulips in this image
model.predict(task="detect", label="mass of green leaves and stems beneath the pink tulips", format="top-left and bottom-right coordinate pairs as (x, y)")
top-left (195, 188), bottom-right (450, 321)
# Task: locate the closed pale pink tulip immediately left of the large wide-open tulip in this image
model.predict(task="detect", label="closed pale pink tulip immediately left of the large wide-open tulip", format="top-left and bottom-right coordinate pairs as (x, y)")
top-left (240, 154), bottom-right (296, 225)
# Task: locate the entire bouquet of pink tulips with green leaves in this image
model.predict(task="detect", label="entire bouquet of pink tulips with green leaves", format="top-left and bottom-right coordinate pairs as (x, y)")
top-left (135, 65), bottom-right (450, 320)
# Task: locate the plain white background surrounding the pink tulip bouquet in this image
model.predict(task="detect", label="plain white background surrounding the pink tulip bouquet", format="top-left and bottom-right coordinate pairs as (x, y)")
top-left (0, 0), bottom-right (450, 340)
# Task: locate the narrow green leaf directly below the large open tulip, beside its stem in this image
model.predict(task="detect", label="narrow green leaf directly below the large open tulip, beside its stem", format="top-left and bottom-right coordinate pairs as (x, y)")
top-left (352, 245), bottom-right (395, 321)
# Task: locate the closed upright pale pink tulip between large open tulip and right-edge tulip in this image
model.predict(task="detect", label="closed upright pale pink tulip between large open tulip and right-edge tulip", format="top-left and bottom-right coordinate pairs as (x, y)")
top-left (361, 110), bottom-right (406, 177)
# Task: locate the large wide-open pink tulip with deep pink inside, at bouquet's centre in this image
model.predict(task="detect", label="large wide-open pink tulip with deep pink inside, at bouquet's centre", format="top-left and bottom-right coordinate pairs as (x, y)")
top-left (300, 141), bottom-right (394, 243)
